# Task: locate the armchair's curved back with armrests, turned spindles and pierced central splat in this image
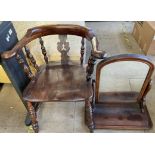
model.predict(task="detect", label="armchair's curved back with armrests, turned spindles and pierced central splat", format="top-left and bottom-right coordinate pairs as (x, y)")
top-left (1, 24), bottom-right (105, 79)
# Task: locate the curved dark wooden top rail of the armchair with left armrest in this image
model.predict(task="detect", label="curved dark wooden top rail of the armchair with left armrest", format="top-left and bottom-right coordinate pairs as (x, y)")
top-left (1, 24), bottom-right (97, 59)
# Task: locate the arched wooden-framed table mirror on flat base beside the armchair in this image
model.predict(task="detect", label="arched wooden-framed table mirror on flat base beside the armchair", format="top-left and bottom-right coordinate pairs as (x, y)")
top-left (85, 54), bottom-right (154, 132)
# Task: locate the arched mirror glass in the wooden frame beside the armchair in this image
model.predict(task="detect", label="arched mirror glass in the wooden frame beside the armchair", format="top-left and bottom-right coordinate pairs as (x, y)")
top-left (99, 61), bottom-right (149, 101)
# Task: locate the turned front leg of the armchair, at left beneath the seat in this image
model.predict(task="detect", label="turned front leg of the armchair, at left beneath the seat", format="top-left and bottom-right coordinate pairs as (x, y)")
top-left (28, 102), bottom-right (39, 133)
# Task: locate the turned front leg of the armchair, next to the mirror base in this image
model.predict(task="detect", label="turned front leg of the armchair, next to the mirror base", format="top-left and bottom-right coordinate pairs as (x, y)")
top-left (85, 100), bottom-right (95, 133)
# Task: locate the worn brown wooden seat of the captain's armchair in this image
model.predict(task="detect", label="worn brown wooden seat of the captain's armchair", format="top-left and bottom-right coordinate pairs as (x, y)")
top-left (23, 63), bottom-right (92, 102)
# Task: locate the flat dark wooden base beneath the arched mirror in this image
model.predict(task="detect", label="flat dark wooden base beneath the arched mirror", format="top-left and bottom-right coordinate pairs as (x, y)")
top-left (93, 103), bottom-right (152, 130)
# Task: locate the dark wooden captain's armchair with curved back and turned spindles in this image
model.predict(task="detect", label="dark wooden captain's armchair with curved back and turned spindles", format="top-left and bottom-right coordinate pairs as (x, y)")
top-left (1, 25), bottom-right (105, 132)
